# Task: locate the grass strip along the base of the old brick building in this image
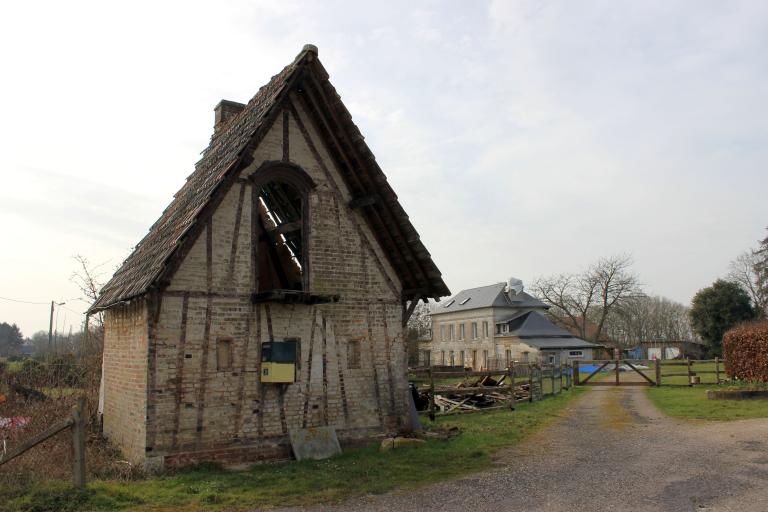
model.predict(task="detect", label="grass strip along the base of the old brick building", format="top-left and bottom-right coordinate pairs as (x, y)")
top-left (0, 388), bottom-right (584, 512)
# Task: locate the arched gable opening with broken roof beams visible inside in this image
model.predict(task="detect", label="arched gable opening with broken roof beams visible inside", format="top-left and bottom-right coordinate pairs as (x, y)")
top-left (249, 162), bottom-right (315, 296)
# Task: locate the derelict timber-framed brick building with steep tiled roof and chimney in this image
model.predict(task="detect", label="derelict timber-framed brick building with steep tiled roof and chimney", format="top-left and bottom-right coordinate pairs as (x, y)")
top-left (91, 45), bottom-right (449, 466)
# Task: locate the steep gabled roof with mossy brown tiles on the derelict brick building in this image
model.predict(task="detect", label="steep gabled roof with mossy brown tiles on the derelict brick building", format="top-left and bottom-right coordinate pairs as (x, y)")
top-left (90, 45), bottom-right (450, 311)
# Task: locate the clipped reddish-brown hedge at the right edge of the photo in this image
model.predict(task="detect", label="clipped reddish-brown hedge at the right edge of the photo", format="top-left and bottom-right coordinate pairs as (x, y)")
top-left (723, 321), bottom-right (768, 382)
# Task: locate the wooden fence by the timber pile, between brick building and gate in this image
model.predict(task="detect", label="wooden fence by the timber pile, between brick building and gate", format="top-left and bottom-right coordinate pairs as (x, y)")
top-left (409, 363), bottom-right (573, 419)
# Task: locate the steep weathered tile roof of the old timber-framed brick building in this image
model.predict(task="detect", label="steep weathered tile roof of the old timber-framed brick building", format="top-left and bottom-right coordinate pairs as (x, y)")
top-left (91, 45), bottom-right (450, 311)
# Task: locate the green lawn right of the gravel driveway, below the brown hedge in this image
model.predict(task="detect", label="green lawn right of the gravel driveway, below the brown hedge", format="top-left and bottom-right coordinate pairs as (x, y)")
top-left (648, 383), bottom-right (768, 421)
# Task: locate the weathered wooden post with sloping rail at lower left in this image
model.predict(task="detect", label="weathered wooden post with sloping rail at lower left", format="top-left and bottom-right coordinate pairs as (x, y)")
top-left (0, 397), bottom-right (85, 488)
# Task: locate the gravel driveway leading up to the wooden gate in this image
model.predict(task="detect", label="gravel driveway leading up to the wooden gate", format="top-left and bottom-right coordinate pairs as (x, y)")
top-left (272, 387), bottom-right (768, 512)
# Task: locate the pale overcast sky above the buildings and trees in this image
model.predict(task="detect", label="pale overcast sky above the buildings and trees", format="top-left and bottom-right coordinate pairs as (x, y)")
top-left (0, 0), bottom-right (768, 335)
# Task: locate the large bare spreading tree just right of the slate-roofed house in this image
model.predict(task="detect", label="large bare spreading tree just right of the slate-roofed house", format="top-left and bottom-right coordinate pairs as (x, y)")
top-left (532, 255), bottom-right (642, 341)
